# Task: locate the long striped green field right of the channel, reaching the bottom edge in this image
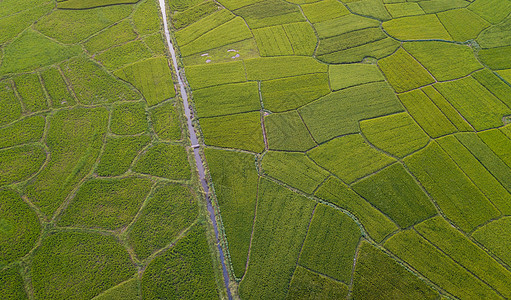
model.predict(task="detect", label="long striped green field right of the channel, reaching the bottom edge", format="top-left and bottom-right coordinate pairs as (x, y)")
top-left (240, 179), bottom-right (314, 299)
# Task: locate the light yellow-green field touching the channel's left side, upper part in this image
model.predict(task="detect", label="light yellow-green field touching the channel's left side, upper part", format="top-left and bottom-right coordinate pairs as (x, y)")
top-left (114, 57), bottom-right (176, 106)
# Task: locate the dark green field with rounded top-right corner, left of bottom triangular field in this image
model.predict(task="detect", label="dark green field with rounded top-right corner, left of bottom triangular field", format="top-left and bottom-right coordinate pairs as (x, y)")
top-left (299, 204), bottom-right (360, 283)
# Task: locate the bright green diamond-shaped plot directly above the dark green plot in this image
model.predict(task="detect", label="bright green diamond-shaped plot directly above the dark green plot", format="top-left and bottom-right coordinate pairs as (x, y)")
top-left (308, 134), bottom-right (394, 183)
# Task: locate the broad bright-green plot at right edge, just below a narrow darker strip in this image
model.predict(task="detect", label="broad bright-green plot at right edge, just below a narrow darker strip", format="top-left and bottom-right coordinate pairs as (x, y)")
top-left (434, 77), bottom-right (511, 130)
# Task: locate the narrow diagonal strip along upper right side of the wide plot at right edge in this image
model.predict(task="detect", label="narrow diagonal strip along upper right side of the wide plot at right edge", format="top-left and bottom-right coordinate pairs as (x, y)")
top-left (437, 135), bottom-right (511, 215)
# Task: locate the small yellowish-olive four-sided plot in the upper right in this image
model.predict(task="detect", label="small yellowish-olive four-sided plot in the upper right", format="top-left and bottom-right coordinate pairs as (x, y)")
top-left (378, 48), bottom-right (435, 93)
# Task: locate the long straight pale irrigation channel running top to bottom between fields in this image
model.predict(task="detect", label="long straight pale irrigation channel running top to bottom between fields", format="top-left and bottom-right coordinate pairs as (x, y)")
top-left (159, 0), bottom-right (232, 300)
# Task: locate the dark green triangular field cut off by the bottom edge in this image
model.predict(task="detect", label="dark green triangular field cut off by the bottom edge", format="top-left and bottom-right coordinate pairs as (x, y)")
top-left (353, 241), bottom-right (438, 299)
